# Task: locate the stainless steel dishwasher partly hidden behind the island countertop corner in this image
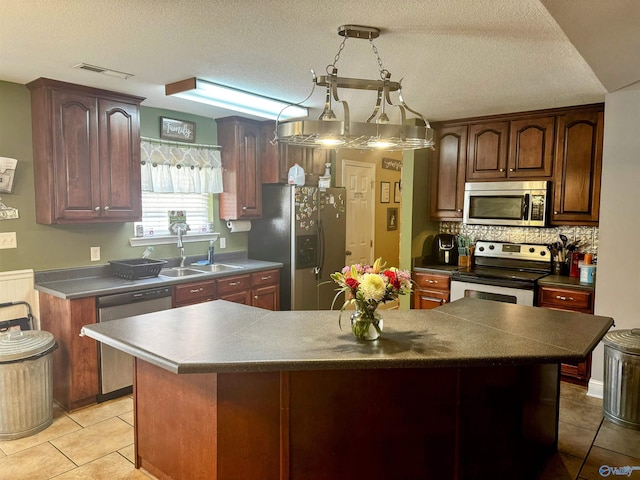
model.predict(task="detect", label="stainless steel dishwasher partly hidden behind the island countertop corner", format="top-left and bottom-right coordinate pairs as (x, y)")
top-left (97, 287), bottom-right (171, 402)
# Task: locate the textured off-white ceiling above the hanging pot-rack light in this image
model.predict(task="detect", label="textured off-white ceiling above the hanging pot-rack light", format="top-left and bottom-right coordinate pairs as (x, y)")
top-left (0, 0), bottom-right (640, 121)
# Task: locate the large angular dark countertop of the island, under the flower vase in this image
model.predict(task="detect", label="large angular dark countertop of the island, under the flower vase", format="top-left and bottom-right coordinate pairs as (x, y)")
top-left (82, 298), bottom-right (613, 373)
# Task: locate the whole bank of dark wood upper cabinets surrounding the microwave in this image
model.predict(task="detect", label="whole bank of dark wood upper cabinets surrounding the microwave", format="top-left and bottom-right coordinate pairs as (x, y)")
top-left (429, 104), bottom-right (604, 226)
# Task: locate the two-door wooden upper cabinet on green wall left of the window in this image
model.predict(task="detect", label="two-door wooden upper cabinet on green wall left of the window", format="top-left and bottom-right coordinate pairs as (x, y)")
top-left (27, 78), bottom-right (144, 224)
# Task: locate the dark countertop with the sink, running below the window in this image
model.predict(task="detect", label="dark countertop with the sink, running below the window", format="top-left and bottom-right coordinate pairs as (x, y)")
top-left (35, 257), bottom-right (282, 300)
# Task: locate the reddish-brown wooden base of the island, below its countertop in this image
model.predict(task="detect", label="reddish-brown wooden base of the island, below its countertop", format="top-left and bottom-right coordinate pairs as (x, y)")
top-left (134, 359), bottom-right (559, 480)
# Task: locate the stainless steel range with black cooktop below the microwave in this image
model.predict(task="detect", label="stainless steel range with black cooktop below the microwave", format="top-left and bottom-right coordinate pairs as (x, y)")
top-left (451, 240), bottom-right (552, 306)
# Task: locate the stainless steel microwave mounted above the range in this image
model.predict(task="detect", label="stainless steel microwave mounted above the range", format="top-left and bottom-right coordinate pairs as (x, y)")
top-left (463, 181), bottom-right (551, 227)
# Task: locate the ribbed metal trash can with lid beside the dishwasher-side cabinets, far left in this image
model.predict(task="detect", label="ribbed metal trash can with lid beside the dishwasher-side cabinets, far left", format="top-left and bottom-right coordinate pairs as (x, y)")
top-left (0, 330), bottom-right (58, 440)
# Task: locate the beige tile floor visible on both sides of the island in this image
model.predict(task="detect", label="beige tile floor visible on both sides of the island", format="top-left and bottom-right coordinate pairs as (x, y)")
top-left (0, 383), bottom-right (640, 480)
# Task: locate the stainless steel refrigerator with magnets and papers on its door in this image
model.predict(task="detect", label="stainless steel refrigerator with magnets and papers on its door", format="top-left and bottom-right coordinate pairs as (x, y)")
top-left (248, 185), bottom-right (346, 310)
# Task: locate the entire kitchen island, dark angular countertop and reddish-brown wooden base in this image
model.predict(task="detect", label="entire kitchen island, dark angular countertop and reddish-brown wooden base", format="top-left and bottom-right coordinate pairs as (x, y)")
top-left (82, 299), bottom-right (613, 480)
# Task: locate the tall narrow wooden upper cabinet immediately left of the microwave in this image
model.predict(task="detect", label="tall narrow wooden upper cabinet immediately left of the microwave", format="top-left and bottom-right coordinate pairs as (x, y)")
top-left (429, 125), bottom-right (467, 221)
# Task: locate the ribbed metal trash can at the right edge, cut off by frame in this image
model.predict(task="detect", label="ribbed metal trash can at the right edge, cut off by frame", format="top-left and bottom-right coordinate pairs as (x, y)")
top-left (603, 328), bottom-right (640, 430)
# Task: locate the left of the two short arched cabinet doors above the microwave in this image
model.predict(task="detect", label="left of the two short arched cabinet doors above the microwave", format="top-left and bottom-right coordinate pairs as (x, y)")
top-left (467, 121), bottom-right (509, 181)
